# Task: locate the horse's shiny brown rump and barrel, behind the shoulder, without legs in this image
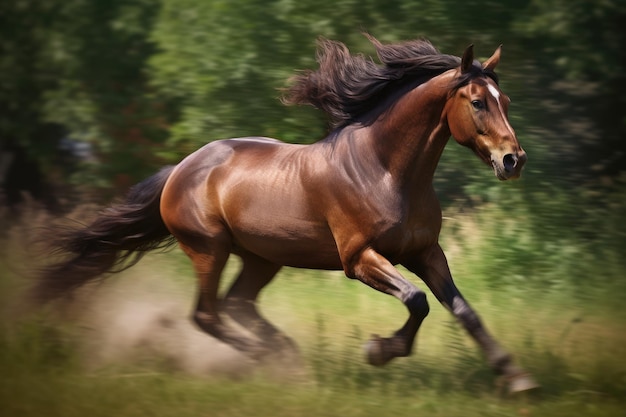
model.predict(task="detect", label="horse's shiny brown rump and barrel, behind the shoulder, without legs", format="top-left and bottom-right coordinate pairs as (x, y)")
top-left (161, 138), bottom-right (341, 269)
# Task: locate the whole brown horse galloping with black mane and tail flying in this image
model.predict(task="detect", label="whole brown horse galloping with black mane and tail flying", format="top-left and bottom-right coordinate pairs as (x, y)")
top-left (34, 37), bottom-right (536, 391)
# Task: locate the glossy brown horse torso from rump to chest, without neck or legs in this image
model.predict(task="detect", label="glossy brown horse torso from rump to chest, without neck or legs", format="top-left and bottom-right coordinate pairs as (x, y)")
top-left (161, 131), bottom-right (441, 269)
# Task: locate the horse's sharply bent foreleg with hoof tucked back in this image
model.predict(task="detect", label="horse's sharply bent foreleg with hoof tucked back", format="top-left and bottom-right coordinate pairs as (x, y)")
top-left (347, 249), bottom-right (429, 366)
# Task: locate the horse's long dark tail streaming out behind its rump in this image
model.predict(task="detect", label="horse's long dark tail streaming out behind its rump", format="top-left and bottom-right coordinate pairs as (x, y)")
top-left (31, 166), bottom-right (175, 303)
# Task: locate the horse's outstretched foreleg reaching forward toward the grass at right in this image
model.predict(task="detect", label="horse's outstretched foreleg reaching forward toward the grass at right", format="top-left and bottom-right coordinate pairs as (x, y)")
top-left (404, 245), bottom-right (537, 391)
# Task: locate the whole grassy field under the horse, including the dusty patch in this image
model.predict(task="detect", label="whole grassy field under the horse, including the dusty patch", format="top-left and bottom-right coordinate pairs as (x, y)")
top-left (0, 208), bottom-right (626, 417)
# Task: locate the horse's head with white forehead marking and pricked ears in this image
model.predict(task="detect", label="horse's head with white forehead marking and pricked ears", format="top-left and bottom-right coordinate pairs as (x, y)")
top-left (446, 46), bottom-right (527, 180)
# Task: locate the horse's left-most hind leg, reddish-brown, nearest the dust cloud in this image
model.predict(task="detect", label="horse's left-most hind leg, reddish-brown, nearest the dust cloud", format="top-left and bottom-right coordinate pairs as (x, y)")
top-left (177, 236), bottom-right (265, 358)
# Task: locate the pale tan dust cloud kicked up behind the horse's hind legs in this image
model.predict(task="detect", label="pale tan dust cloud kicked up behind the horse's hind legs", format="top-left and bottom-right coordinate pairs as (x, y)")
top-left (33, 255), bottom-right (258, 377)
